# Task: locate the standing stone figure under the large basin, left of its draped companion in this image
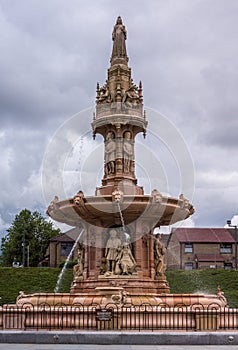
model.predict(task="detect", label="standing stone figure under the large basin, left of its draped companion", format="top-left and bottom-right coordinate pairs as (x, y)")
top-left (105, 229), bottom-right (121, 274)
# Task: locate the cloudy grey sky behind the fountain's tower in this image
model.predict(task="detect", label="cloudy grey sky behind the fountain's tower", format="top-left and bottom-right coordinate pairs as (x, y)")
top-left (0, 0), bottom-right (238, 235)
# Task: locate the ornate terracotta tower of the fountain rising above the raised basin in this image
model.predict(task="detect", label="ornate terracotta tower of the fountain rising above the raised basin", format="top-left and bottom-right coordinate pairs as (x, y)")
top-left (92, 16), bottom-right (147, 195)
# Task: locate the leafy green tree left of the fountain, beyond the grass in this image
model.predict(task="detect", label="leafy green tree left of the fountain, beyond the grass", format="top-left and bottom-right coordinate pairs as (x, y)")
top-left (1, 209), bottom-right (60, 266)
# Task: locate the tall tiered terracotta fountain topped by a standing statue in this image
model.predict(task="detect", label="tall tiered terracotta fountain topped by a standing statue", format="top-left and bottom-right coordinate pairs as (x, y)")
top-left (17, 17), bottom-right (226, 307)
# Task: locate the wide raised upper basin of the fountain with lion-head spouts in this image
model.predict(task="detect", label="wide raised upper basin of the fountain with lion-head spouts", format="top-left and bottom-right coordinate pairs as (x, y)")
top-left (47, 195), bottom-right (194, 227)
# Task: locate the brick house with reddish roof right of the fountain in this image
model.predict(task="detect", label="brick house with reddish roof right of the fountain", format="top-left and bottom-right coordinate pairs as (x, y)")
top-left (166, 228), bottom-right (236, 270)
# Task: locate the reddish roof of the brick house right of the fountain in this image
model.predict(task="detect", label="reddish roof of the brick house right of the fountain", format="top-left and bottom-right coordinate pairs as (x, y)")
top-left (172, 227), bottom-right (235, 243)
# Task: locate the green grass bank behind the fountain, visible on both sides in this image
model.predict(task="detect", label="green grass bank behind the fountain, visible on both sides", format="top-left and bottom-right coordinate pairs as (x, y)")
top-left (0, 267), bottom-right (238, 307)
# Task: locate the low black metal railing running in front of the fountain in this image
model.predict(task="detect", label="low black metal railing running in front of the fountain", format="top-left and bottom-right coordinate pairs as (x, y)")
top-left (0, 303), bottom-right (238, 331)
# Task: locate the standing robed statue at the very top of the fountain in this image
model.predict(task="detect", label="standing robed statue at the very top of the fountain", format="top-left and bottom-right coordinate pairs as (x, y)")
top-left (111, 16), bottom-right (128, 61)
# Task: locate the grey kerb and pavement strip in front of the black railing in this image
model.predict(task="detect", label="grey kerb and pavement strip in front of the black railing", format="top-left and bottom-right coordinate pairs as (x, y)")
top-left (0, 330), bottom-right (238, 350)
